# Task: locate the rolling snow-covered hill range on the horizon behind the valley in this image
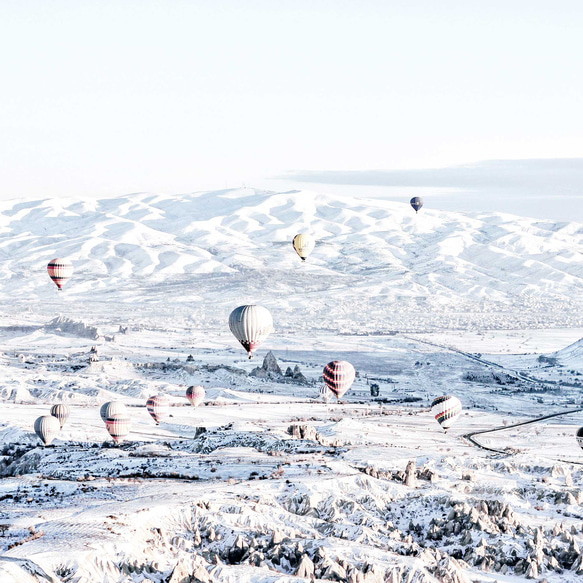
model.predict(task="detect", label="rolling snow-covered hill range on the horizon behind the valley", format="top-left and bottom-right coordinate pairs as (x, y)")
top-left (0, 189), bottom-right (583, 332)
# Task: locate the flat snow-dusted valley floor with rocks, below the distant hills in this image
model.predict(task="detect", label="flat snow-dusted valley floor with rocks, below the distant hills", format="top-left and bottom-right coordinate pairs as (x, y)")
top-left (0, 324), bottom-right (583, 583)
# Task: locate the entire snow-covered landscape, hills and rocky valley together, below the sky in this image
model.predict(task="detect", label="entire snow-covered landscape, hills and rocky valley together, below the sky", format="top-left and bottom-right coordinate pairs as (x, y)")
top-left (0, 189), bottom-right (583, 583)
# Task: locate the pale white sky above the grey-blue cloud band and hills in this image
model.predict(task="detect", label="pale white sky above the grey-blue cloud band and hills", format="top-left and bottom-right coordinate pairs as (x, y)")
top-left (0, 0), bottom-right (583, 198)
